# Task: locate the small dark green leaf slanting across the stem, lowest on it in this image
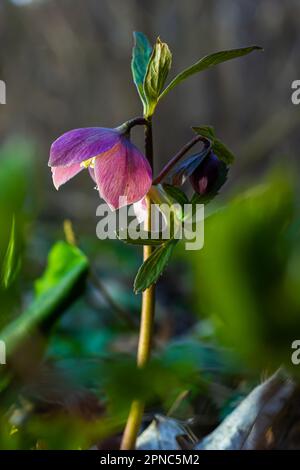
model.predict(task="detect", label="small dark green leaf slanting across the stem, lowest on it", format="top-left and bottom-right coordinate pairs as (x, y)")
top-left (134, 239), bottom-right (178, 294)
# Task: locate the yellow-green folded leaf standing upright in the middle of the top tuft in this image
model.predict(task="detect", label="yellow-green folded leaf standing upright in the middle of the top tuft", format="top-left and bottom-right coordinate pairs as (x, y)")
top-left (144, 38), bottom-right (172, 117)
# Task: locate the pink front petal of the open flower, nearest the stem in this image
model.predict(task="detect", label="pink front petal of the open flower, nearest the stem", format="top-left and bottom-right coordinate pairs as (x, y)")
top-left (95, 137), bottom-right (152, 209)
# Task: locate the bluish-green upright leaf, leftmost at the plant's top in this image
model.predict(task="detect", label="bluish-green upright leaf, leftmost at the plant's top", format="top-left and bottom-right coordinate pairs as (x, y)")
top-left (131, 31), bottom-right (152, 104)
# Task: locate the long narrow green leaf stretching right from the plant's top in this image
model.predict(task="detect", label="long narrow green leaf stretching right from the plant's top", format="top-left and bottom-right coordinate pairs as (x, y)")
top-left (159, 46), bottom-right (262, 99)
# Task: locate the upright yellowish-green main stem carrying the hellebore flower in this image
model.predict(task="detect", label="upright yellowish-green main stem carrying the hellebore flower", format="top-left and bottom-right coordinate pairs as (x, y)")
top-left (121, 120), bottom-right (155, 450)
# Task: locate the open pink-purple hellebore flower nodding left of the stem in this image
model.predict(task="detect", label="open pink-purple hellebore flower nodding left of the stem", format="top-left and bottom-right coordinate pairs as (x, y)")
top-left (48, 124), bottom-right (152, 209)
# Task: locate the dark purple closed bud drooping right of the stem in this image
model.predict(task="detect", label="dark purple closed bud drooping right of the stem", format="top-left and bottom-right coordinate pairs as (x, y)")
top-left (190, 152), bottom-right (227, 196)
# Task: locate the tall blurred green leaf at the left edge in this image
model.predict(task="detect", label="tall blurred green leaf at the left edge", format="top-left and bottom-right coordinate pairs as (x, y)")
top-left (0, 138), bottom-right (35, 327)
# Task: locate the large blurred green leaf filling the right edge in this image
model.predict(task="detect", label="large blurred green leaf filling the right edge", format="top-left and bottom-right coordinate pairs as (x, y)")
top-left (192, 171), bottom-right (300, 370)
